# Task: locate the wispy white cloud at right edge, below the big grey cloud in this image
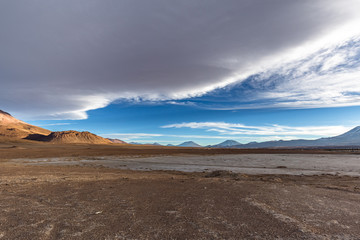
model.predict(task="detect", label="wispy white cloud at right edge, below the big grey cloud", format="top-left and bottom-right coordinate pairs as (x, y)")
top-left (258, 43), bottom-right (360, 108)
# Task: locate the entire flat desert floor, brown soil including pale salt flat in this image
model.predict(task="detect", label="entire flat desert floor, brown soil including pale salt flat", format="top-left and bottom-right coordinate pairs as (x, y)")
top-left (0, 141), bottom-right (360, 239)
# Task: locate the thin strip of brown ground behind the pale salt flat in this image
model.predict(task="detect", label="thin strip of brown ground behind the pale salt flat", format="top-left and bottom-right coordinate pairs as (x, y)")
top-left (0, 139), bottom-right (360, 160)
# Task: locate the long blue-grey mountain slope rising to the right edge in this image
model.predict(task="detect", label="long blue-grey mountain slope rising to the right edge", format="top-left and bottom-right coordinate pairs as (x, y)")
top-left (228, 126), bottom-right (360, 148)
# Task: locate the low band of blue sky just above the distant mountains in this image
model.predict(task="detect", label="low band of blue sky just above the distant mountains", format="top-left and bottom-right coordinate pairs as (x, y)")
top-left (30, 103), bottom-right (360, 145)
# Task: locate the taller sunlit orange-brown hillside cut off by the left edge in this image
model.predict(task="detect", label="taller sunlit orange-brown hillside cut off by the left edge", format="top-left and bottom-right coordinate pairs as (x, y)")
top-left (0, 110), bottom-right (51, 139)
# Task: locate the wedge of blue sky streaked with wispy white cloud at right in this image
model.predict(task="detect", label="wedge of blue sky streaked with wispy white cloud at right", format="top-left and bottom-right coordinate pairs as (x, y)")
top-left (186, 37), bottom-right (360, 109)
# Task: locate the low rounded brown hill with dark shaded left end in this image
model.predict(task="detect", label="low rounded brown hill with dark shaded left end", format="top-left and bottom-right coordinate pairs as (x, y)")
top-left (27, 130), bottom-right (112, 144)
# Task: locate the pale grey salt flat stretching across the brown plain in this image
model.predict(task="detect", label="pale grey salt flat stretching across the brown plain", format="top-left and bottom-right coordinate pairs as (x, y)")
top-left (12, 154), bottom-right (360, 176)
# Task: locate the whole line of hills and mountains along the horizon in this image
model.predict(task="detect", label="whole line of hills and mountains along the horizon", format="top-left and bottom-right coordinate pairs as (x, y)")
top-left (0, 110), bottom-right (360, 148)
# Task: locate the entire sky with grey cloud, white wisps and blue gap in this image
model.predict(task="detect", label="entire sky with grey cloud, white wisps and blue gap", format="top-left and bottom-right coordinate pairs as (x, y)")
top-left (0, 0), bottom-right (360, 145)
